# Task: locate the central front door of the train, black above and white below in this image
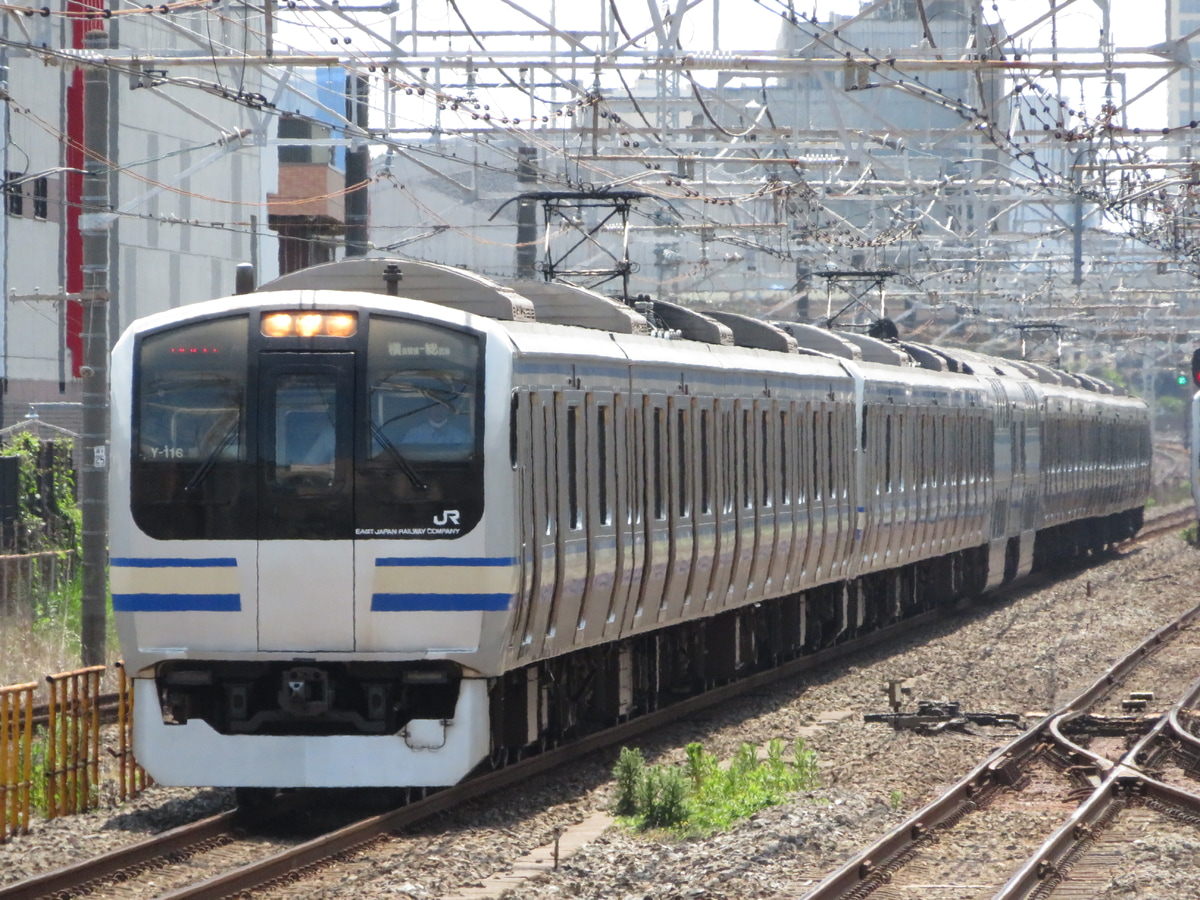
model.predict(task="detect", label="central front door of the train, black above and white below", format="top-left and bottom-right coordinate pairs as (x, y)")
top-left (257, 352), bottom-right (354, 652)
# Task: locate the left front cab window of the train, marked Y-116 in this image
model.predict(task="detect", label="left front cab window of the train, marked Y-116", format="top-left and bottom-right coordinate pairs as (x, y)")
top-left (131, 316), bottom-right (254, 540)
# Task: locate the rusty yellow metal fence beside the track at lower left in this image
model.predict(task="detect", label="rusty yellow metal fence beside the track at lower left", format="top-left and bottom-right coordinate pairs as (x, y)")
top-left (0, 666), bottom-right (150, 842)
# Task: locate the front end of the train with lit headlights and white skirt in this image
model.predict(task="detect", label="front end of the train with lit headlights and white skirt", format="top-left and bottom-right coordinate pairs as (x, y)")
top-left (110, 292), bottom-right (517, 787)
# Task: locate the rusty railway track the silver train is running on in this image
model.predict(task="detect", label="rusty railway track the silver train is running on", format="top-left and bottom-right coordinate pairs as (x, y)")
top-left (7, 509), bottom-right (1200, 900)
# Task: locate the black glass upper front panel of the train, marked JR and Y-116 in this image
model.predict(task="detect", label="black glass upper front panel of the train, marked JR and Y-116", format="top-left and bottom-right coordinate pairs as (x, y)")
top-left (131, 316), bottom-right (482, 540)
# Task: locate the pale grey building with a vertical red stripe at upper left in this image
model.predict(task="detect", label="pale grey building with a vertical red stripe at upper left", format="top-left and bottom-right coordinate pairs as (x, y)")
top-left (0, 0), bottom-right (278, 431)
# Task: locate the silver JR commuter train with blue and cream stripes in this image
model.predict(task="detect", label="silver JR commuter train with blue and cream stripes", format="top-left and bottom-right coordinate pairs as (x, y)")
top-left (109, 257), bottom-right (1151, 796)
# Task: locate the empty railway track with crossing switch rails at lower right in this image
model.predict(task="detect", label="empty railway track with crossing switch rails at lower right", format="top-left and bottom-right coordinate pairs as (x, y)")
top-left (804, 592), bottom-right (1200, 900)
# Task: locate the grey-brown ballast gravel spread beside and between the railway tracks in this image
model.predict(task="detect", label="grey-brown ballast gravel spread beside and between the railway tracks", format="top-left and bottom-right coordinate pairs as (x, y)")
top-left (7, 525), bottom-right (1200, 900)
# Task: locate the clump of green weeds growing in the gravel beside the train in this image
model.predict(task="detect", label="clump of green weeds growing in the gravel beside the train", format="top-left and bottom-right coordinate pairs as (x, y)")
top-left (613, 739), bottom-right (817, 836)
